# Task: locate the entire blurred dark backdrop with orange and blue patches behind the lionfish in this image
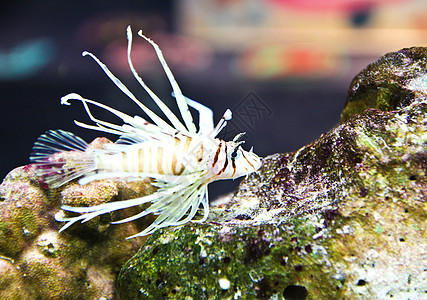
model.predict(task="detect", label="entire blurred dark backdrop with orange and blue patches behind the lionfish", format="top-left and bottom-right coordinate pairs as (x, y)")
top-left (0, 0), bottom-right (427, 196)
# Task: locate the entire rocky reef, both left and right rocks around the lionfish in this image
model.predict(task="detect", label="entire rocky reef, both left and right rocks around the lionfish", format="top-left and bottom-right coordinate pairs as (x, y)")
top-left (0, 48), bottom-right (427, 299)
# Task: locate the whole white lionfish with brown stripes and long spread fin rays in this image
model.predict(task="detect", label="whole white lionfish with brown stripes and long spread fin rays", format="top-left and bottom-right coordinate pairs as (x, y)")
top-left (30, 26), bottom-right (261, 238)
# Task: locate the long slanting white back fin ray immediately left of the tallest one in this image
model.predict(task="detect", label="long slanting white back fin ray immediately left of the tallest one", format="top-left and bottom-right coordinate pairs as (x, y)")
top-left (82, 51), bottom-right (174, 131)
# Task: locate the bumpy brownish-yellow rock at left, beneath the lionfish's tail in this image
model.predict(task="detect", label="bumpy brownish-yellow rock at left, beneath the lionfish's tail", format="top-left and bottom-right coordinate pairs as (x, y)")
top-left (0, 139), bottom-right (152, 300)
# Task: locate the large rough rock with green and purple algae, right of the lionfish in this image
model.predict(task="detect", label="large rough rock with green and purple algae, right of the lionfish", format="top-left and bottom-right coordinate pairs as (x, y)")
top-left (117, 48), bottom-right (427, 299)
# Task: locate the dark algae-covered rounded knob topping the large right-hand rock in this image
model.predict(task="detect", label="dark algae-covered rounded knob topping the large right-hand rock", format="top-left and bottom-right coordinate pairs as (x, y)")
top-left (341, 47), bottom-right (427, 121)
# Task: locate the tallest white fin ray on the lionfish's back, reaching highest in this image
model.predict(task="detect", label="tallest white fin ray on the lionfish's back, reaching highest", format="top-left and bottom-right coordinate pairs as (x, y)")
top-left (126, 25), bottom-right (188, 132)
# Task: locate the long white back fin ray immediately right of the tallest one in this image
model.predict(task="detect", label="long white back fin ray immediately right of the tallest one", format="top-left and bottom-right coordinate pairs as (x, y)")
top-left (138, 30), bottom-right (197, 134)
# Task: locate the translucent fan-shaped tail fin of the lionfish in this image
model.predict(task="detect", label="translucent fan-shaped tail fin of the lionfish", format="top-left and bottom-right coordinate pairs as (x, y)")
top-left (30, 130), bottom-right (95, 188)
